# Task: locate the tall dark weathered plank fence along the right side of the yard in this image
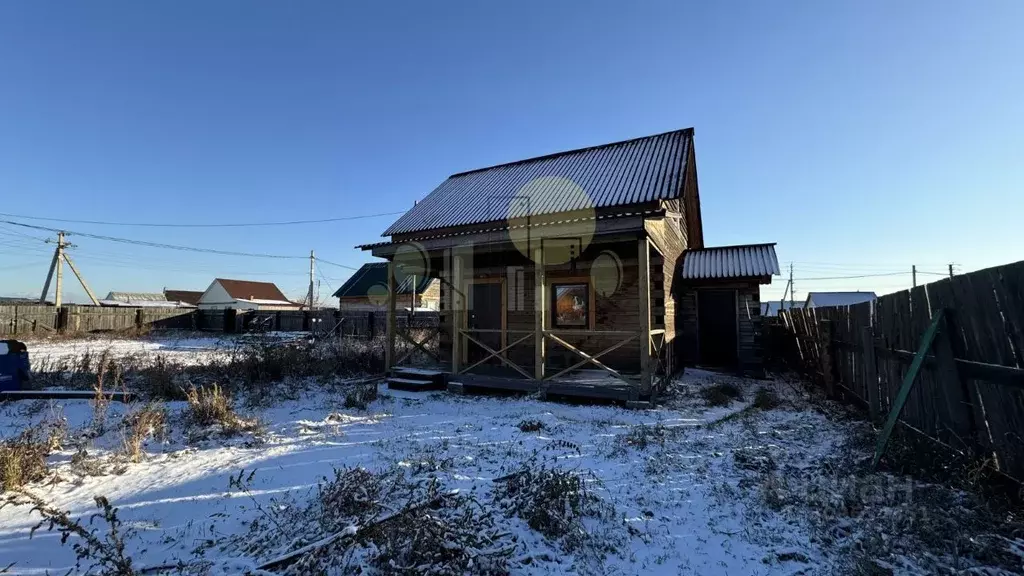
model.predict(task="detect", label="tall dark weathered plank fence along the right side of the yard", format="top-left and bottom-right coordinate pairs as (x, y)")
top-left (766, 261), bottom-right (1024, 481)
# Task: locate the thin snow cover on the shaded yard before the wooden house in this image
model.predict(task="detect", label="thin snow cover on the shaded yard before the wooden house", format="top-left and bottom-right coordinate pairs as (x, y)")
top-left (0, 339), bottom-right (1024, 575)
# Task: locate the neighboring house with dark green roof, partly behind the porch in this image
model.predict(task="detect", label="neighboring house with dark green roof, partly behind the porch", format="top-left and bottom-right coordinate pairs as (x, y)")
top-left (334, 262), bottom-right (440, 311)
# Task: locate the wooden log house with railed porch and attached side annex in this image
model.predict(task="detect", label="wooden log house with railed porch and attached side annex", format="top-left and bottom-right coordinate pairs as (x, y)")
top-left (360, 129), bottom-right (778, 401)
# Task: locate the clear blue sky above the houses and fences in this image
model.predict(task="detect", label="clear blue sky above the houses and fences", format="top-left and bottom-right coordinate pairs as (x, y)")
top-left (0, 0), bottom-right (1024, 298)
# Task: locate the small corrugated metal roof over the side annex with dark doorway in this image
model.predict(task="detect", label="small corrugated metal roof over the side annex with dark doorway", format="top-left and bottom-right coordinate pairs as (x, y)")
top-left (682, 244), bottom-right (780, 280)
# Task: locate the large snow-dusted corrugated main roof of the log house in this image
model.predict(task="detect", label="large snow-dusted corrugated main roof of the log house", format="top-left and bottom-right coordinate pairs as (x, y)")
top-left (382, 128), bottom-right (693, 236)
